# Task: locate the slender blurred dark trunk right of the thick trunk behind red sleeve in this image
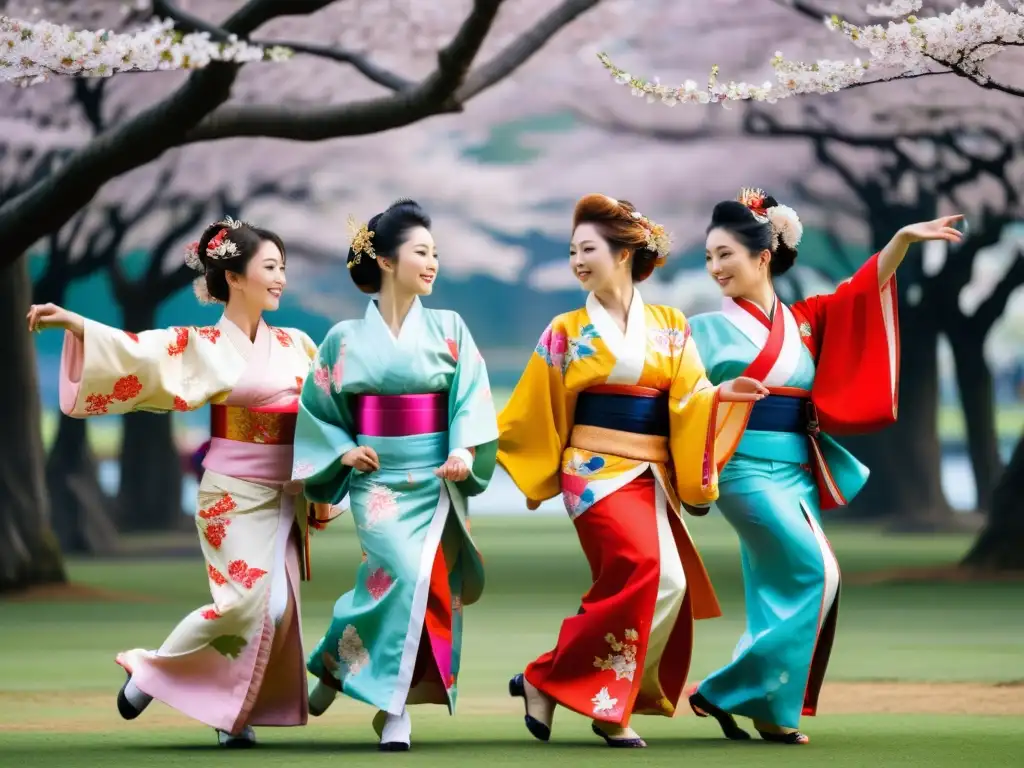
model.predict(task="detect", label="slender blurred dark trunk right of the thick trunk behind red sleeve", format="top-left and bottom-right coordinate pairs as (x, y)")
top-left (946, 324), bottom-right (1002, 512)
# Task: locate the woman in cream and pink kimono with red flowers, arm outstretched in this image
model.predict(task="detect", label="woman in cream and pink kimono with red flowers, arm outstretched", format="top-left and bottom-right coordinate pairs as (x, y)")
top-left (28, 218), bottom-right (330, 746)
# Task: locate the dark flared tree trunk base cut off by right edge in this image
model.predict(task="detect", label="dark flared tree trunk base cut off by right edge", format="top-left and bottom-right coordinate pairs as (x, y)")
top-left (963, 434), bottom-right (1024, 570)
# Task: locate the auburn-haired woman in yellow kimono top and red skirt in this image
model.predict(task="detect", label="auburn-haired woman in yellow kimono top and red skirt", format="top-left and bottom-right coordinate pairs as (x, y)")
top-left (498, 195), bottom-right (762, 748)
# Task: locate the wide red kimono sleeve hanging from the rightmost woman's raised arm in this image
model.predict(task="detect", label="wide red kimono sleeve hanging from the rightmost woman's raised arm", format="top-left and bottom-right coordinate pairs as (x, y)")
top-left (790, 254), bottom-right (899, 435)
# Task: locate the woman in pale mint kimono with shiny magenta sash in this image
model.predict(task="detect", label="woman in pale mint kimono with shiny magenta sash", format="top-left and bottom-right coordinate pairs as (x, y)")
top-left (294, 201), bottom-right (498, 751)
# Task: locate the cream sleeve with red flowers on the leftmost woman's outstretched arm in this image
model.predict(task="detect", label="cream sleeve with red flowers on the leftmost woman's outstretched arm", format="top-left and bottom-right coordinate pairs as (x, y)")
top-left (59, 319), bottom-right (232, 418)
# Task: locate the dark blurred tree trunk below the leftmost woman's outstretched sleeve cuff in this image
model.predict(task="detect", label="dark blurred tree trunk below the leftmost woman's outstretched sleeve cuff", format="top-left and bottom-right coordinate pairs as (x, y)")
top-left (46, 414), bottom-right (118, 555)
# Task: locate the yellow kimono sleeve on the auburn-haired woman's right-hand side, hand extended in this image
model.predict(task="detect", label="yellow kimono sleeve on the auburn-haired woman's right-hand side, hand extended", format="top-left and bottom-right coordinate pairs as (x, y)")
top-left (669, 312), bottom-right (746, 514)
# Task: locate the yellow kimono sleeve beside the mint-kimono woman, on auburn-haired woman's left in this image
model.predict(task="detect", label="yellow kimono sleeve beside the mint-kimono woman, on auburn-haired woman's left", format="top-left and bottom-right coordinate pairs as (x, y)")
top-left (498, 318), bottom-right (577, 502)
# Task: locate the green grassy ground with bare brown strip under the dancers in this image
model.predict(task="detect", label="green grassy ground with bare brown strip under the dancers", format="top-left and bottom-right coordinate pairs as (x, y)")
top-left (0, 516), bottom-right (1024, 768)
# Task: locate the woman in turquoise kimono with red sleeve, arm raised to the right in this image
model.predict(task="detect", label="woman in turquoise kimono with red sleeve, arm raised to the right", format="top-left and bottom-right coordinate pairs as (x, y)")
top-left (689, 189), bottom-right (961, 744)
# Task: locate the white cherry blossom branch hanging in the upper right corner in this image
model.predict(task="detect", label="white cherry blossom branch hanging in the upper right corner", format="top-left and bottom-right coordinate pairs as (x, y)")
top-left (599, 0), bottom-right (1024, 106)
